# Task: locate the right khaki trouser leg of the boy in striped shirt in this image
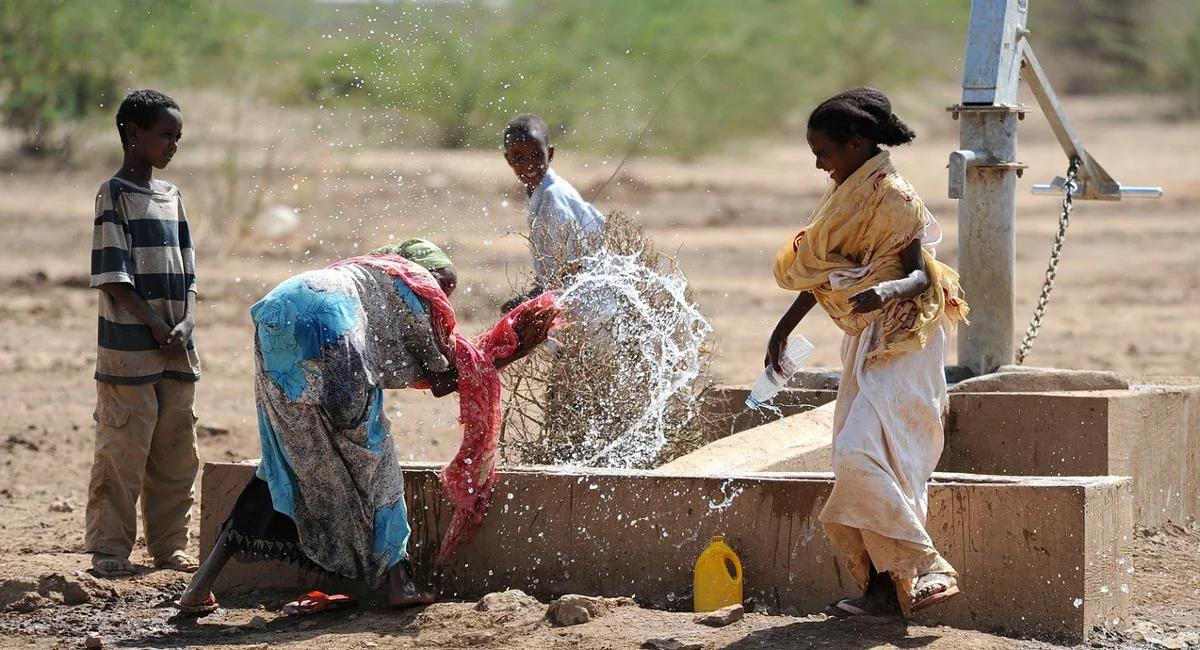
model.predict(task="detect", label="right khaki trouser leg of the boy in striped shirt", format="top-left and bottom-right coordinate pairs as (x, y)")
top-left (142, 379), bottom-right (200, 570)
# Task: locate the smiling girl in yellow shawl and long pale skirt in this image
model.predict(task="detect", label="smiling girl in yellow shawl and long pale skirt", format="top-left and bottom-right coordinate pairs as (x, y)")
top-left (766, 88), bottom-right (967, 615)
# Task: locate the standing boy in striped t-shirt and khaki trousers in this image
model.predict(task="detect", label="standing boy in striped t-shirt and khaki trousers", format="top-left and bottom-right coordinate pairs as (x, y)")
top-left (85, 90), bottom-right (200, 577)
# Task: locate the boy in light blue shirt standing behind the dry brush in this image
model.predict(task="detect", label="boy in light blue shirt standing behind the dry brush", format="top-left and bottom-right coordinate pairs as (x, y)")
top-left (504, 113), bottom-right (605, 312)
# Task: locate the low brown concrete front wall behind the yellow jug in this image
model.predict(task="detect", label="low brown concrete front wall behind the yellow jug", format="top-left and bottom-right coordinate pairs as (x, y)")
top-left (200, 463), bottom-right (1132, 642)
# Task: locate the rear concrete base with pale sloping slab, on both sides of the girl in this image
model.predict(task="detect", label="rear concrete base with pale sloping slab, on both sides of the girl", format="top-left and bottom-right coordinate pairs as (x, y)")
top-left (691, 378), bottom-right (1200, 528)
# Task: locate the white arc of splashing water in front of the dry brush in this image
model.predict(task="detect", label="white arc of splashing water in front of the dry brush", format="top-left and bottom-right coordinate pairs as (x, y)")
top-left (549, 249), bottom-right (713, 468)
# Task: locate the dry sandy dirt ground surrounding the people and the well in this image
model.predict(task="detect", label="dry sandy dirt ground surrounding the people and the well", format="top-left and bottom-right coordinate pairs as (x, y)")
top-left (0, 89), bottom-right (1200, 649)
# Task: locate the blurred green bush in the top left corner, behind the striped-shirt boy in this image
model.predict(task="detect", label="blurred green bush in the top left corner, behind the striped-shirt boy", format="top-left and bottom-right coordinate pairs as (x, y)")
top-left (0, 0), bottom-right (262, 156)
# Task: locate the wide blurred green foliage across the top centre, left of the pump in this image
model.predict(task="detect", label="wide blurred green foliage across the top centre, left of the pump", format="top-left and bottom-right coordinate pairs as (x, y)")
top-left (302, 0), bottom-right (966, 156)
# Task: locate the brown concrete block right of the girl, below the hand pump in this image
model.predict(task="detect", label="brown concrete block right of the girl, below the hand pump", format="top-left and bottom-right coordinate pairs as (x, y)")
top-left (937, 388), bottom-right (1200, 528)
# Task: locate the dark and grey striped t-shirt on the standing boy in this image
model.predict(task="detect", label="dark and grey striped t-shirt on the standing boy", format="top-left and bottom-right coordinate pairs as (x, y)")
top-left (91, 177), bottom-right (200, 384)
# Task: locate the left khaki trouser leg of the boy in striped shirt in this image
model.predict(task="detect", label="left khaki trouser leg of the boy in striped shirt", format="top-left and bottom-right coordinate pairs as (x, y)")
top-left (84, 381), bottom-right (158, 558)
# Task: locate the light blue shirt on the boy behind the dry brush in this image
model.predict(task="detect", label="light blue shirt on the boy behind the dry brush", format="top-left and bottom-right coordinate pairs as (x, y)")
top-left (529, 169), bottom-right (605, 288)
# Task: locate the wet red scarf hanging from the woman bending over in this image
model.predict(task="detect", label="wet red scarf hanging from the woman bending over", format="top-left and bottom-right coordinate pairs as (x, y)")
top-left (330, 255), bottom-right (556, 564)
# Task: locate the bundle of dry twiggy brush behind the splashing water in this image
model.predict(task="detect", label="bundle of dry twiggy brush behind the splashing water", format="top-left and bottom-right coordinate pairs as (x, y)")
top-left (503, 212), bottom-right (713, 468)
